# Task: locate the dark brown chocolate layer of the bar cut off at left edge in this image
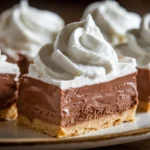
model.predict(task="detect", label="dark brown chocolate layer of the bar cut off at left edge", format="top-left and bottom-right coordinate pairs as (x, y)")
top-left (0, 74), bottom-right (18, 109)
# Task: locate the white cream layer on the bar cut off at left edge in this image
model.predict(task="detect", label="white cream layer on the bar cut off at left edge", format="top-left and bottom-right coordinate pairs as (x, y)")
top-left (0, 51), bottom-right (20, 81)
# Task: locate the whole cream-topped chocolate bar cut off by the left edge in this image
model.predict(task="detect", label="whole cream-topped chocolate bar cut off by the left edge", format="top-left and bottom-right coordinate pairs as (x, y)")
top-left (0, 54), bottom-right (20, 120)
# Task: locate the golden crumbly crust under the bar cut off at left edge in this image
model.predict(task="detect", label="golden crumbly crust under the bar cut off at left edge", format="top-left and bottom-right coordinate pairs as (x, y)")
top-left (0, 103), bottom-right (18, 120)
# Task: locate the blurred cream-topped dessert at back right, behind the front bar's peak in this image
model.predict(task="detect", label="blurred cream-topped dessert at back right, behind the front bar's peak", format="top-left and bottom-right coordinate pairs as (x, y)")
top-left (82, 0), bottom-right (141, 45)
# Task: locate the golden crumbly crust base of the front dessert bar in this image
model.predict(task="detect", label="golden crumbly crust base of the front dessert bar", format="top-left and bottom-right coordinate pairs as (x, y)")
top-left (18, 106), bottom-right (137, 138)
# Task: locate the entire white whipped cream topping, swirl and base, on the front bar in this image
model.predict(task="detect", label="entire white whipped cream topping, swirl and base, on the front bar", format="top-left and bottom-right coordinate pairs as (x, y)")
top-left (28, 15), bottom-right (136, 89)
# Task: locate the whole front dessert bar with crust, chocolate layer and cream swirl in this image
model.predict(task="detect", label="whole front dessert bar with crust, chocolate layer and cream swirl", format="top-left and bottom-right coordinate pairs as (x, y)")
top-left (17, 15), bottom-right (138, 137)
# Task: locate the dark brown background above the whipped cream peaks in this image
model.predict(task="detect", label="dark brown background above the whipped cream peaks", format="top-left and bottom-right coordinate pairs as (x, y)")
top-left (0, 0), bottom-right (150, 23)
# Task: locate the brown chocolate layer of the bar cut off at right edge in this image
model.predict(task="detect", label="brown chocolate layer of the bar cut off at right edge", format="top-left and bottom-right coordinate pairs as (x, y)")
top-left (137, 68), bottom-right (150, 102)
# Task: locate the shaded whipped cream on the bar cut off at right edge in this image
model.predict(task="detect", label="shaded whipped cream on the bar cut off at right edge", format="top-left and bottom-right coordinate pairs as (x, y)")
top-left (116, 14), bottom-right (150, 69)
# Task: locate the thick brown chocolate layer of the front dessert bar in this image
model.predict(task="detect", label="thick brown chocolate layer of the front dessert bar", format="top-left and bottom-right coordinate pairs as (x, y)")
top-left (17, 73), bottom-right (138, 127)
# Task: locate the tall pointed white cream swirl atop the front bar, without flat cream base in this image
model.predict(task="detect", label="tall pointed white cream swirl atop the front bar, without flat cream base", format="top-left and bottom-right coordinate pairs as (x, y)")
top-left (34, 15), bottom-right (118, 79)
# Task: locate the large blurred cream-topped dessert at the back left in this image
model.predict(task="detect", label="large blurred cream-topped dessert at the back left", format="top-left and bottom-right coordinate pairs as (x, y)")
top-left (0, 0), bottom-right (64, 73)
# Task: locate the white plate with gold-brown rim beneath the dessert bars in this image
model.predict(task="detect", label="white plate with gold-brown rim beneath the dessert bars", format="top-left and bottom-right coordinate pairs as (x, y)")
top-left (0, 113), bottom-right (150, 150)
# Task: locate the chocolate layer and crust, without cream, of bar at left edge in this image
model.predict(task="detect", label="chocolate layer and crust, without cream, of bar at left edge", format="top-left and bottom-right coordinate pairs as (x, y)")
top-left (0, 74), bottom-right (18, 120)
